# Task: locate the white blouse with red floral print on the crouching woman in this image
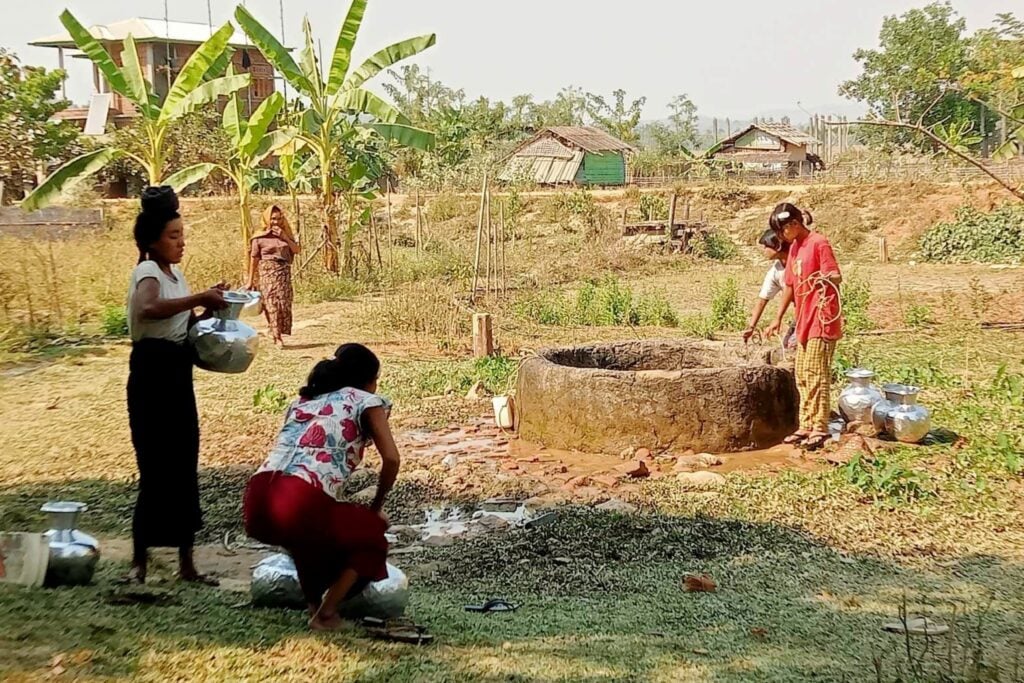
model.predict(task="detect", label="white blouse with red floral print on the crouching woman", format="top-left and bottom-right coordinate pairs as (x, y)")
top-left (259, 388), bottom-right (391, 501)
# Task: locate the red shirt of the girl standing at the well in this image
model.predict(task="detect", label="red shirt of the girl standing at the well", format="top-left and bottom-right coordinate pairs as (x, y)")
top-left (785, 232), bottom-right (843, 344)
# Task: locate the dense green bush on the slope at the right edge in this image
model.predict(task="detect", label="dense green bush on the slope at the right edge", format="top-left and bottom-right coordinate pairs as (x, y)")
top-left (921, 204), bottom-right (1024, 263)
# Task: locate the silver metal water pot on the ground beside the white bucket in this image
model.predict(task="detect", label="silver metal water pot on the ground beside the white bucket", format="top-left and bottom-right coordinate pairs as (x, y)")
top-left (42, 503), bottom-right (99, 587)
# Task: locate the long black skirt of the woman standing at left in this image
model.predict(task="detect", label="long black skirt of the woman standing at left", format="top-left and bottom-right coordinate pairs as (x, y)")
top-left (128, 339), bottom-right (203, 548)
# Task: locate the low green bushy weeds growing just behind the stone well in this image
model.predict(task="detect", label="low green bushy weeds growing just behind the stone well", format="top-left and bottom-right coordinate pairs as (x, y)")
top-left (516, 275), bottom-right (679, 327)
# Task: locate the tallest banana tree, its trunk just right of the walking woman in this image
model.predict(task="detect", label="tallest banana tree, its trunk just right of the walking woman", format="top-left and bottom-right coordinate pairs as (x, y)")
top-left (234, 0), bottom-right (436, 272)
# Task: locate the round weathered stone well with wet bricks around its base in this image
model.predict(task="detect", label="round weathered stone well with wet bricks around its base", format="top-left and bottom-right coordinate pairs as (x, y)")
top-left (516, 340), bottom-right (799, 455)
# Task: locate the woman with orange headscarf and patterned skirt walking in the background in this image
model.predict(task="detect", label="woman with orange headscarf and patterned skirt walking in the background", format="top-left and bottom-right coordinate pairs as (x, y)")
top-left (248, 205), bottom-right (302, 348)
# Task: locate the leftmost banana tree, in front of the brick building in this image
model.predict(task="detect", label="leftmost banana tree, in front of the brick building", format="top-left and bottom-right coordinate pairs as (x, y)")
top-left (22, 10), bottom-right (249, 211)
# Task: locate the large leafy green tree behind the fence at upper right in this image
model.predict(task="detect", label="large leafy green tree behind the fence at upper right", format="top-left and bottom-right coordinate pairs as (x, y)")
top-left (840, 2), bottom-right (978, 148)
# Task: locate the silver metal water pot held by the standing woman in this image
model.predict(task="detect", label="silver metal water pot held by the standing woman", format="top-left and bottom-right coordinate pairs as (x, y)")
top-left (188, 292), bottom-right (259, 374)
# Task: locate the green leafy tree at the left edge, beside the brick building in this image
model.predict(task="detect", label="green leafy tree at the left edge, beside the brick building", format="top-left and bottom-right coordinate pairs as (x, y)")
top-left (0, 48), bottom-right (81, 201)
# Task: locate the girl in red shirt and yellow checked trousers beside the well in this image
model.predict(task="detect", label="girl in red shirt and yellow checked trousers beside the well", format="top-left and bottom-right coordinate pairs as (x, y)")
top-left (767, 203), bottom-right (843, 449)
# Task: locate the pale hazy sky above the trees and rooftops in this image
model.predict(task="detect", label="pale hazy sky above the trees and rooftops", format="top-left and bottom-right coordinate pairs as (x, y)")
top-left (6, 0), bottom-right (1022, 119)
